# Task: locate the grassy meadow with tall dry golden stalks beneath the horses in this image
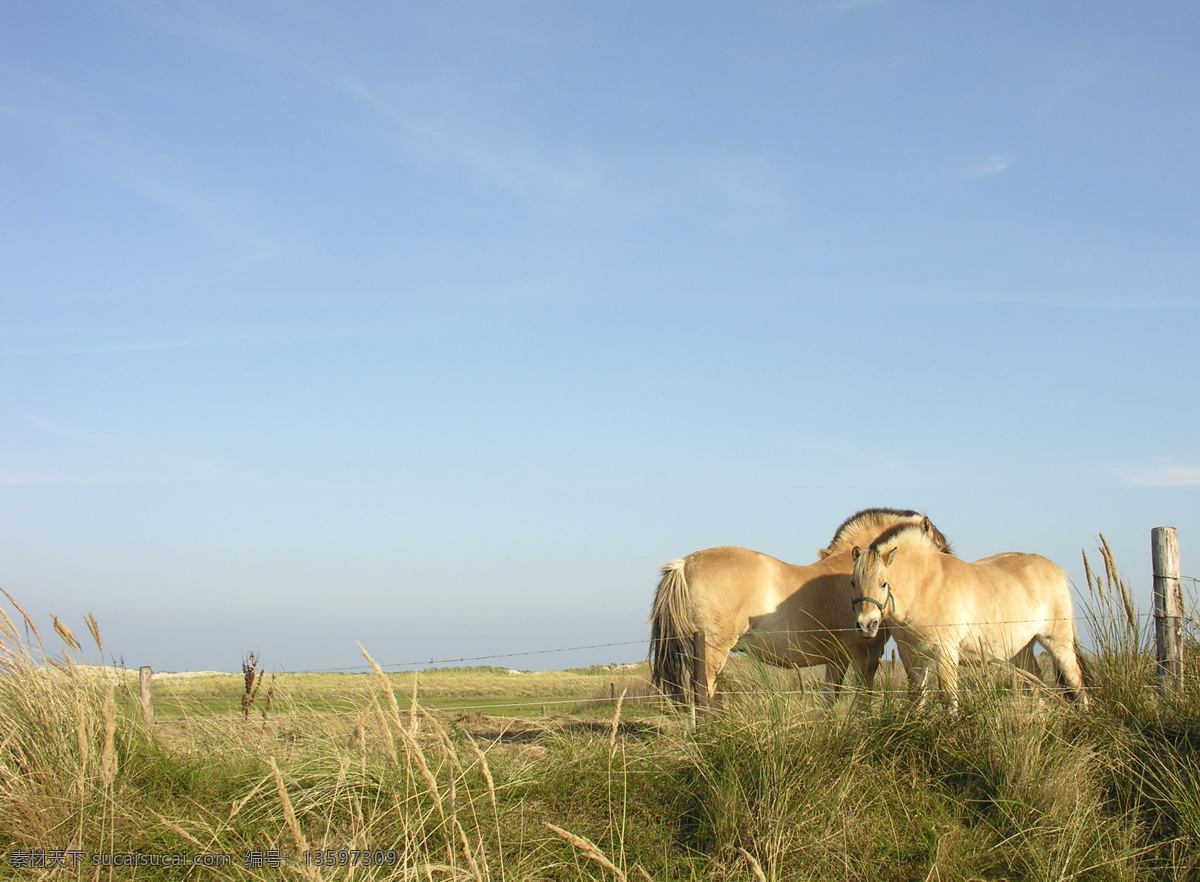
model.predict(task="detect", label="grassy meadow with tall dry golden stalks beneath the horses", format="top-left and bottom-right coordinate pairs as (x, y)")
top-left (0, 544), bottom-right (1200, 882)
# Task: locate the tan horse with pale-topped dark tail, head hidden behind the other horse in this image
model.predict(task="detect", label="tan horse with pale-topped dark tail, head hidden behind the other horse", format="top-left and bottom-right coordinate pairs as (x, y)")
top-left (649, 509), bottom-right (952, 701)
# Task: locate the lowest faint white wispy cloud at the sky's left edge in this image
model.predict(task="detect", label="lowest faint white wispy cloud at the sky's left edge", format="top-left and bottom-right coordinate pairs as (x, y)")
top-left (0, 414), bottom-right (228, 487)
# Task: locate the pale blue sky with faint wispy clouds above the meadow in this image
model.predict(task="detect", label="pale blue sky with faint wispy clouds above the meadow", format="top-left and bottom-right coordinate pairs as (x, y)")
top-left (0, 0), bottom-right (1200, 670)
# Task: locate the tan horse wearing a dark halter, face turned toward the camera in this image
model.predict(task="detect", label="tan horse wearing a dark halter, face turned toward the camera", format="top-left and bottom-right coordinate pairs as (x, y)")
top-left (851, 522), bottom-right (1087, 708)
